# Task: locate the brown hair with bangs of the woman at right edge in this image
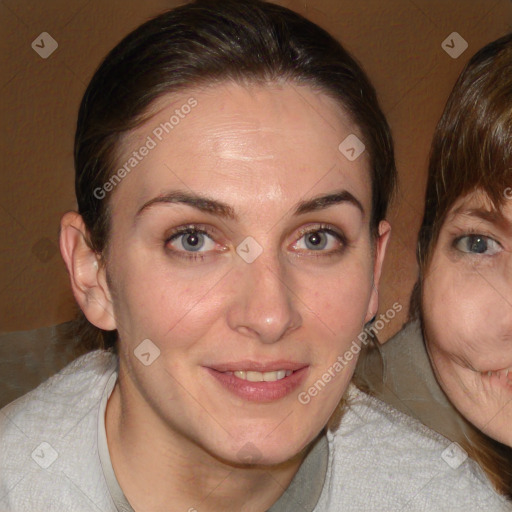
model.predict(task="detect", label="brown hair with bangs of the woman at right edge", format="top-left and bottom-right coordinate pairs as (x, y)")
top-left (410, 33), bottom-right (512, 498)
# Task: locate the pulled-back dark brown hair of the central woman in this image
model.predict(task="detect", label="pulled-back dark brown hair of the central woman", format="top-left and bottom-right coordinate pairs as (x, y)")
top-left (68, 0), bottom-right (396, 352)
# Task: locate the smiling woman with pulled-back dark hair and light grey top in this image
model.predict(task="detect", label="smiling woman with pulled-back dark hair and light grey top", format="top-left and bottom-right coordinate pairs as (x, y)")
top-left (0, 0), bottom-right (505, 512)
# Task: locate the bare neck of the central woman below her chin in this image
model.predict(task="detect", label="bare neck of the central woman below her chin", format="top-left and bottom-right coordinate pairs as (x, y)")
top-left (105, 368), bottom-right (307, 512)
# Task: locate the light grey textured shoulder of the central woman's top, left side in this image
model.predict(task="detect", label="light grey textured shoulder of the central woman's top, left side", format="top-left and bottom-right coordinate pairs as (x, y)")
top-left (0, 350), bottom-right (117, 510)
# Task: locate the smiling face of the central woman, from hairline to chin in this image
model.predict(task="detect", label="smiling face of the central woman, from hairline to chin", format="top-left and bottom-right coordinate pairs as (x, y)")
top-left (101, 84), bottom-right (389, 464)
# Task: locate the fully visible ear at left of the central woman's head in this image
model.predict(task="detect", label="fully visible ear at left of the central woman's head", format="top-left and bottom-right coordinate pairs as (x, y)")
top-left (60, 212), bottom-right (116, 331)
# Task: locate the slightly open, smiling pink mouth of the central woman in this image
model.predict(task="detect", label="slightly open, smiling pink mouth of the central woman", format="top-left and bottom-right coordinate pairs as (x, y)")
top-left (204, 362), bottom-right (309, 402)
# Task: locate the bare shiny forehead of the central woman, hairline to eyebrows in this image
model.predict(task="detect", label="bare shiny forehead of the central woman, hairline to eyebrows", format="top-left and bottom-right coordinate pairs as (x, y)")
top-left (109, 84), bottom-right (371, 220)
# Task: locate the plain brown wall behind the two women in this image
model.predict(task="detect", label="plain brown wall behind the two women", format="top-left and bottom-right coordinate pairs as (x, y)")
top-left (0, 0), bottom-right (512, 340)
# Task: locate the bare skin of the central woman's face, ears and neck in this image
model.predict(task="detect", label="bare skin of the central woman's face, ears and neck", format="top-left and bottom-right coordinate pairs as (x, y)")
top-left (61, 83), bottom-right (390, 511)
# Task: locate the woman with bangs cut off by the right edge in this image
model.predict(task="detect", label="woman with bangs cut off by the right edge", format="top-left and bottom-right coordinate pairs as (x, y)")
top-left (360, 34), bottom-right (512, 498)
